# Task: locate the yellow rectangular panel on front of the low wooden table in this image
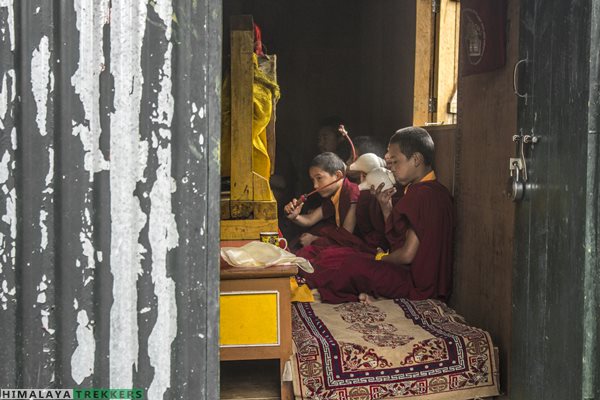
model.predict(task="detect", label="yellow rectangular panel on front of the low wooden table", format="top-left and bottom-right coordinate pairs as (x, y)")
top-left (220, 292), bottom-right (279, 346)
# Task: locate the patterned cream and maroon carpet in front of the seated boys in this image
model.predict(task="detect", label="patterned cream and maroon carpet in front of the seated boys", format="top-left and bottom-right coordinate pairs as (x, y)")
top-left (292, 299), bottom-right (498, 400)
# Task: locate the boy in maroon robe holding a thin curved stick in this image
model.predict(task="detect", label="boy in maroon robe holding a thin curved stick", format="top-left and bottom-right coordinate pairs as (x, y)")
top-left (284, 152), bottom-right (359, 246)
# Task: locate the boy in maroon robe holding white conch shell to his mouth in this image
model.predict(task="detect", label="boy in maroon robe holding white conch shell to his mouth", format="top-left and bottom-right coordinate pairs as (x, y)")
top-left (306, 127), bottom-right (453, 303)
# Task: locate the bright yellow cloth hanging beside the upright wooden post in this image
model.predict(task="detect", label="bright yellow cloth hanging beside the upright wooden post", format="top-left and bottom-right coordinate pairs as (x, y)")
top-left (252, 54), bottom-right (279, 198)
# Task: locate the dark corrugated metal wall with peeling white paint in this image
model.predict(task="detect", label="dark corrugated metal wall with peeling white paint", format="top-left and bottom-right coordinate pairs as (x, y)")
top-left (0, 0), bottom-right (222, 400)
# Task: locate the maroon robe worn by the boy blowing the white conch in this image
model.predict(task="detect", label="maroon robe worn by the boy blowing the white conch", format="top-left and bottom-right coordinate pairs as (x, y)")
top-left (299, 181), bottom-right (454, 303)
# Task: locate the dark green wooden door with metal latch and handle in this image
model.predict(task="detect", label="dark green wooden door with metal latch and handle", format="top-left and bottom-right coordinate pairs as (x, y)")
top-left (509, 0), bottom-right (600, 400)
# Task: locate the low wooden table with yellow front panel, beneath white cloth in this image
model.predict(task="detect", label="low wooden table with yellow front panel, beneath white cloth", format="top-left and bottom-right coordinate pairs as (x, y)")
top-left (220, 241), bottom-right (298, 400)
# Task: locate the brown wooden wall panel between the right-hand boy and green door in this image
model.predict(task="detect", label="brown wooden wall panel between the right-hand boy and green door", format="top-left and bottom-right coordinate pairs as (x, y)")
top-left (451, 0), bottom-right (516, 398)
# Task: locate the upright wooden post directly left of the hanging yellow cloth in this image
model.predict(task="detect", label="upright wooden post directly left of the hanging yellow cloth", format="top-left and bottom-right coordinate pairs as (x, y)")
top-left (231, 15), bottom-right (254, 200)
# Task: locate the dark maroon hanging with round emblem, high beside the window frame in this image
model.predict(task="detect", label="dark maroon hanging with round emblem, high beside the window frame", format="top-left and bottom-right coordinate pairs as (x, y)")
top-left (460, 0), bottom-right (506, 76)
